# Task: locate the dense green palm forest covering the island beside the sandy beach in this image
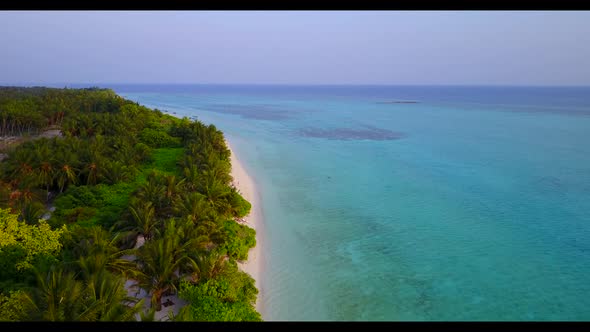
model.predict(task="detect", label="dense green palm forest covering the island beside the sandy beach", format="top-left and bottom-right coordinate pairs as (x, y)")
top-left (0, 88), bottom-right (260, 321)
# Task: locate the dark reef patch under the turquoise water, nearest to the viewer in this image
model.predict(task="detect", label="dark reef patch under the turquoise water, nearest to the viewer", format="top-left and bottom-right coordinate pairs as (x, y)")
top-left (299, 126), bottom-right (406, 141)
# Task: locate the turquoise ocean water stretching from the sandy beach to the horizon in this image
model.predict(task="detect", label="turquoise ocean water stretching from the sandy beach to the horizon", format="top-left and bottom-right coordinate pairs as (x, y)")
top-left (111, 85), bottom-right (590, 321)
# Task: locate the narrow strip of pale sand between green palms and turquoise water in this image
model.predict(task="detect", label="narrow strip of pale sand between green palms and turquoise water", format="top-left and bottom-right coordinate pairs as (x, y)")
top-left (225, 138), bottom-right (264, 319)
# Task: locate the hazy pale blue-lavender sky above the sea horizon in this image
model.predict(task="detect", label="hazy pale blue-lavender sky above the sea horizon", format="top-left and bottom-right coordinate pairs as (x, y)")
top-left (0, 11), bottom-right (590, 85)
